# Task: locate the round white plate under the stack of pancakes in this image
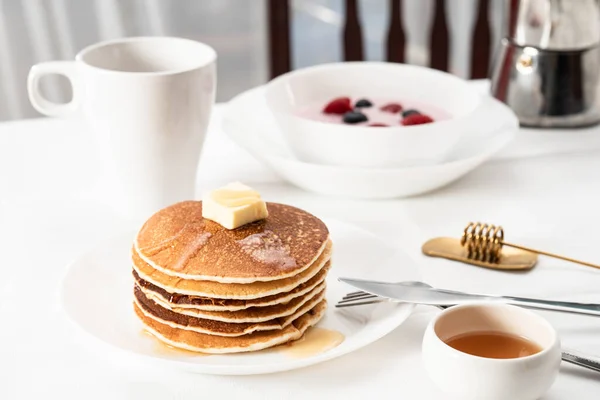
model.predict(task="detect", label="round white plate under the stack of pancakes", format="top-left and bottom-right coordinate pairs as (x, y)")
top-left (61, 221), bottom-right (418, 375)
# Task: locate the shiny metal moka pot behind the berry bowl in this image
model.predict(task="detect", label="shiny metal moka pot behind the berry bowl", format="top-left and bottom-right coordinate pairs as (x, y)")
top-left (491, 0), bottom-right (600, 128)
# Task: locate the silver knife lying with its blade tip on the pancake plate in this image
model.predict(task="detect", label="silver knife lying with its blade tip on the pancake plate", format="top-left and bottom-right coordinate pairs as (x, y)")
top-left (338, 278), bottom-right (600, 316)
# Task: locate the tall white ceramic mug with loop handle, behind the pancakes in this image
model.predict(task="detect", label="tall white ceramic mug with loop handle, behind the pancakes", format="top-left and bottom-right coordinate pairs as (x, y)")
top-left (27, 37), bottom-right (216, 219)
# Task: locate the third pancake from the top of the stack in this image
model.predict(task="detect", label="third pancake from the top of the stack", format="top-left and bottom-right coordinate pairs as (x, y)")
top-left (132, 262), bottom-right (330, 313)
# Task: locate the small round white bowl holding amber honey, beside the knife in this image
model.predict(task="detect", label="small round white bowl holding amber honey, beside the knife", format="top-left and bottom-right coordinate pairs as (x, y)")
top-left (423, 303), bottom-right (561, 400)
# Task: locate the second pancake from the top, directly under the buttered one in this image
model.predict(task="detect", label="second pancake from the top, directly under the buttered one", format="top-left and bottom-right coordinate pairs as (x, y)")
top-left (132, 241), bottom-right (332, 300)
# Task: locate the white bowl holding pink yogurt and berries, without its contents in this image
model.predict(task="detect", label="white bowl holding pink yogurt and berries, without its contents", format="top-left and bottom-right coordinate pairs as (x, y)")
top-left (265, 62), bottom-right (482, 168)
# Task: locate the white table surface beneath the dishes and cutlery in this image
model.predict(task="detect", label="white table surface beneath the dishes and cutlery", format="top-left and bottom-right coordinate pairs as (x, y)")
top-left (0, 107), bottom-right (600, 400)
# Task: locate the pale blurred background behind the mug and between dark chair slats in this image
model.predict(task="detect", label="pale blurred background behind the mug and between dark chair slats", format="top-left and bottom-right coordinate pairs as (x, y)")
top-left (0, 0), bottom-right (507, 120)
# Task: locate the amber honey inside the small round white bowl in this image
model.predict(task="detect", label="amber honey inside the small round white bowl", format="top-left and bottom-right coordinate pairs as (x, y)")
top-left (445, 332), bottom-right (542, 358)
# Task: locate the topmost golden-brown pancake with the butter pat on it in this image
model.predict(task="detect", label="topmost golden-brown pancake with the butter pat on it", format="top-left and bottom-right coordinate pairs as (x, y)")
top-left (134, 201), bottom-right (329, 286)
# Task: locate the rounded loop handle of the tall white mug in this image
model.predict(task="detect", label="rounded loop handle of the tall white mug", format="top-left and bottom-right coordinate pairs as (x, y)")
top-left (27, 61), bottom-right (79, 117)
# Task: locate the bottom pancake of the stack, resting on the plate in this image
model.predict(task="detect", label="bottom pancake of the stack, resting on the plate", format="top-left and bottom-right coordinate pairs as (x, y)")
top-left (134, 300), bottom-right (327, 354)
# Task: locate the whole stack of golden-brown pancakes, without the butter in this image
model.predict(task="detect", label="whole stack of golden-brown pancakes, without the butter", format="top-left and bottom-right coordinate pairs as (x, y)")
top-left (132, 201), bottom-right (331, 353)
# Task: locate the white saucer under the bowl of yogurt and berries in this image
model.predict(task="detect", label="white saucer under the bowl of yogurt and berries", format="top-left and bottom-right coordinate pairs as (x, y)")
top-left (222, 87), bottom-right (518, 199)
